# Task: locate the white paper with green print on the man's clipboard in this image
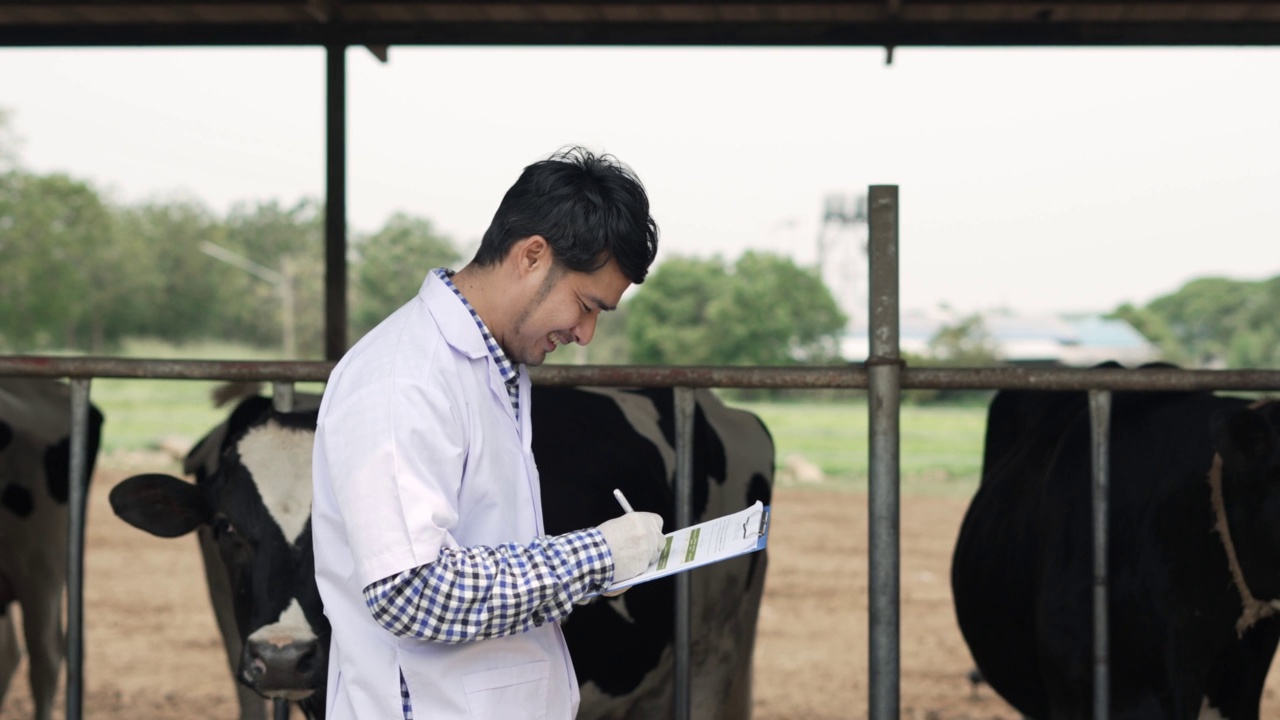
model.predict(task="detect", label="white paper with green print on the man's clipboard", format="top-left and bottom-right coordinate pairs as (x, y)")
top-left (604, 500), bottom-right (769, 592)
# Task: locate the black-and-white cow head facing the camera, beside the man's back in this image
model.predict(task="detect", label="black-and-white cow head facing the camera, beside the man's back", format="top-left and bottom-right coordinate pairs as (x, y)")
top-left (110, 406), bottom-right (329, 702)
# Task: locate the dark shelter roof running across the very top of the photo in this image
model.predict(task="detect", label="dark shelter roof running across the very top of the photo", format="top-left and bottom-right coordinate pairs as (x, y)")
top-left (0, 0), bottom-right (1280, 46)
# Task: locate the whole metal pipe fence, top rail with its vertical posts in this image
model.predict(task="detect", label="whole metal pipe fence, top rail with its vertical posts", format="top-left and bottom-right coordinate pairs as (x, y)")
top-left (0, 352), bottom-right (1280, 720)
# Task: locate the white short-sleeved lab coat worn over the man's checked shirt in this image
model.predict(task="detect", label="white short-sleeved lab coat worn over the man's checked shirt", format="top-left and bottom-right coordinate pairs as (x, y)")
top-left (311, 273), bottom-right (579, 720)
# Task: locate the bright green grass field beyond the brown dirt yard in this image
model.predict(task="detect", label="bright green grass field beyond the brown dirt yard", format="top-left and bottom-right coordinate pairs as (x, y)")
top-left (72, 341), bottom-right (986, 496)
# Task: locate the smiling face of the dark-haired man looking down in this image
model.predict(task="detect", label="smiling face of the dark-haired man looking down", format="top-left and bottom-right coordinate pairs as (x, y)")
top-left (500, 260), bottom-right (631, 365)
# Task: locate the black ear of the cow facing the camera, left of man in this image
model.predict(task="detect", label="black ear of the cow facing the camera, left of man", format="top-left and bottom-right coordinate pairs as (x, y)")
top-left (109, 474), bottom-right (211, 538)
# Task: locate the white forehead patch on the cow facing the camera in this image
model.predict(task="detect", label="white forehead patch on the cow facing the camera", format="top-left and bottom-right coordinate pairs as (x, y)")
top-left (237, 420), bottom-right (315, 543)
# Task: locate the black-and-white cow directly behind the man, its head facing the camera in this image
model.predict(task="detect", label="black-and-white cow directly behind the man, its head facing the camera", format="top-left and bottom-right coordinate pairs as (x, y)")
top-left (111, 386), bottom-right (774, 720)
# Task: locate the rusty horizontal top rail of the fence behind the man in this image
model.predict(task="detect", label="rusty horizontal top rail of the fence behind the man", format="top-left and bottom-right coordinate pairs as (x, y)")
top-left (0, 356), bottom-right (1280, 392)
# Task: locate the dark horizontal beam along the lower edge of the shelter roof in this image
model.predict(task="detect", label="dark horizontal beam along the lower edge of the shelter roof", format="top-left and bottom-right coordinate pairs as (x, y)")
top-left (0, 20), bottom-right (1280, 47)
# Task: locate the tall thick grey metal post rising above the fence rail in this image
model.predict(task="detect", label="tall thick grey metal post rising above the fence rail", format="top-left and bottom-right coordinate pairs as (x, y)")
top-left (867, 184), bottom-right (901, 720)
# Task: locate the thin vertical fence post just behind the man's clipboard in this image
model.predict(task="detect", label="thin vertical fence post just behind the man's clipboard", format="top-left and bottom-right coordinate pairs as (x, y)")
top-left (672, 387), bottom-right (695, 720)
